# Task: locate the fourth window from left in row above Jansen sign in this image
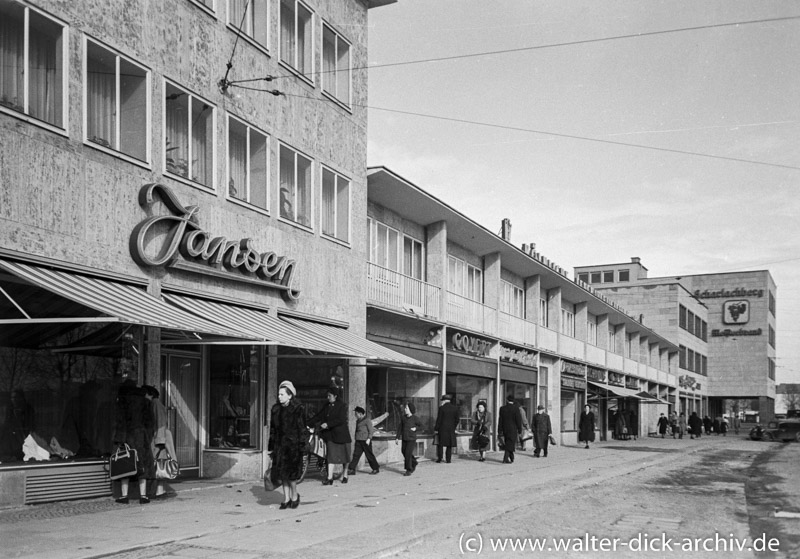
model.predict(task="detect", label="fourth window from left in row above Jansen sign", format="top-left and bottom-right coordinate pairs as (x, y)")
top-left (228, 116), bottom-right (268, 210)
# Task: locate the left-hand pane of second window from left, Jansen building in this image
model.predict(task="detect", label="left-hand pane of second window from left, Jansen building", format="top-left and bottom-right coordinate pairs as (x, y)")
top-left (86, 42), bottom-right (117, 149)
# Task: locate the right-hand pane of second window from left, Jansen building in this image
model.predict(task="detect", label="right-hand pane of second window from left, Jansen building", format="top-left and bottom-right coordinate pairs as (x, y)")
top-left (119, 60), bottom-right (147, 161)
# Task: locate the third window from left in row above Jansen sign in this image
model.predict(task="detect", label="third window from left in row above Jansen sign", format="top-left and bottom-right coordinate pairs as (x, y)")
top-left (164, 82), bottom-right (216, 188)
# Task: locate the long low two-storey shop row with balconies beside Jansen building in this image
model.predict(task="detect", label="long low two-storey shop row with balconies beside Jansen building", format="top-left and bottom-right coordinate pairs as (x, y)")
top-left (367, 167), bottom-right (679, 460)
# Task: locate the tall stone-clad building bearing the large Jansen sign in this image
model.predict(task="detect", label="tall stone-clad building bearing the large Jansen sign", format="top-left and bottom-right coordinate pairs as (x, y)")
top-left (0, 0), bottom-right (412, 504)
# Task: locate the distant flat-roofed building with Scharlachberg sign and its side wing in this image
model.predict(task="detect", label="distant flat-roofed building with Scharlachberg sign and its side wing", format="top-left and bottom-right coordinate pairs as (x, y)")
top-left (575, 258), bottom-right (776, 420)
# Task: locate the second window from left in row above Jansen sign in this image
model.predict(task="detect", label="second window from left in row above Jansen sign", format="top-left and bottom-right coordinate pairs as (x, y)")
top-left (86, 40), bottom-right (150, 161)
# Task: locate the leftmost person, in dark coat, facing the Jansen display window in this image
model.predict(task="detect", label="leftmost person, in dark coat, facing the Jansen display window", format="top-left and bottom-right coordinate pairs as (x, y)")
top-left (113, 378), bottom-right (156, 505)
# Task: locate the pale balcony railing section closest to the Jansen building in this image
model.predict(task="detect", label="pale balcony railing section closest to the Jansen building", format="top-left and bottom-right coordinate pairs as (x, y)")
top-left (367, 263), bottom-right (441, 320)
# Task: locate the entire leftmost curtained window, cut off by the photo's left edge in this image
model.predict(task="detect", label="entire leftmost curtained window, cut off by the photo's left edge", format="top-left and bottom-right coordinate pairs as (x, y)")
top-left (0, 0), bottom-right (69, 130)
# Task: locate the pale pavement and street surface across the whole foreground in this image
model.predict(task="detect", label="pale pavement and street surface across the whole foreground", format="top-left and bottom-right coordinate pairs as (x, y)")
top-left (0, 437), bottom-right (800, 559)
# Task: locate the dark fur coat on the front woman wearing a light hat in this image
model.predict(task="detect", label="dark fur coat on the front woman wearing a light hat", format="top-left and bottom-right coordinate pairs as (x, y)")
top-left (267, 398), bottom-right (309, 482)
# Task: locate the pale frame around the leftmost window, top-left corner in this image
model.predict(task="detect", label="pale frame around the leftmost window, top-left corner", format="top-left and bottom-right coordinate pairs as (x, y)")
top-left (0, 0), bottom-right (69, 136)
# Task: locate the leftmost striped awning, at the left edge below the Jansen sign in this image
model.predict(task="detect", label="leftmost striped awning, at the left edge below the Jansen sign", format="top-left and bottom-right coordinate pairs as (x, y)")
top-left (0, 260), bottom-right (252, 339)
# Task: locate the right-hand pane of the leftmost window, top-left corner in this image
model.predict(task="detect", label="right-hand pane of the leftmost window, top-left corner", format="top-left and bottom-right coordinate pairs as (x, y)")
top-left (27, 10), bottom-right (64, 126)
